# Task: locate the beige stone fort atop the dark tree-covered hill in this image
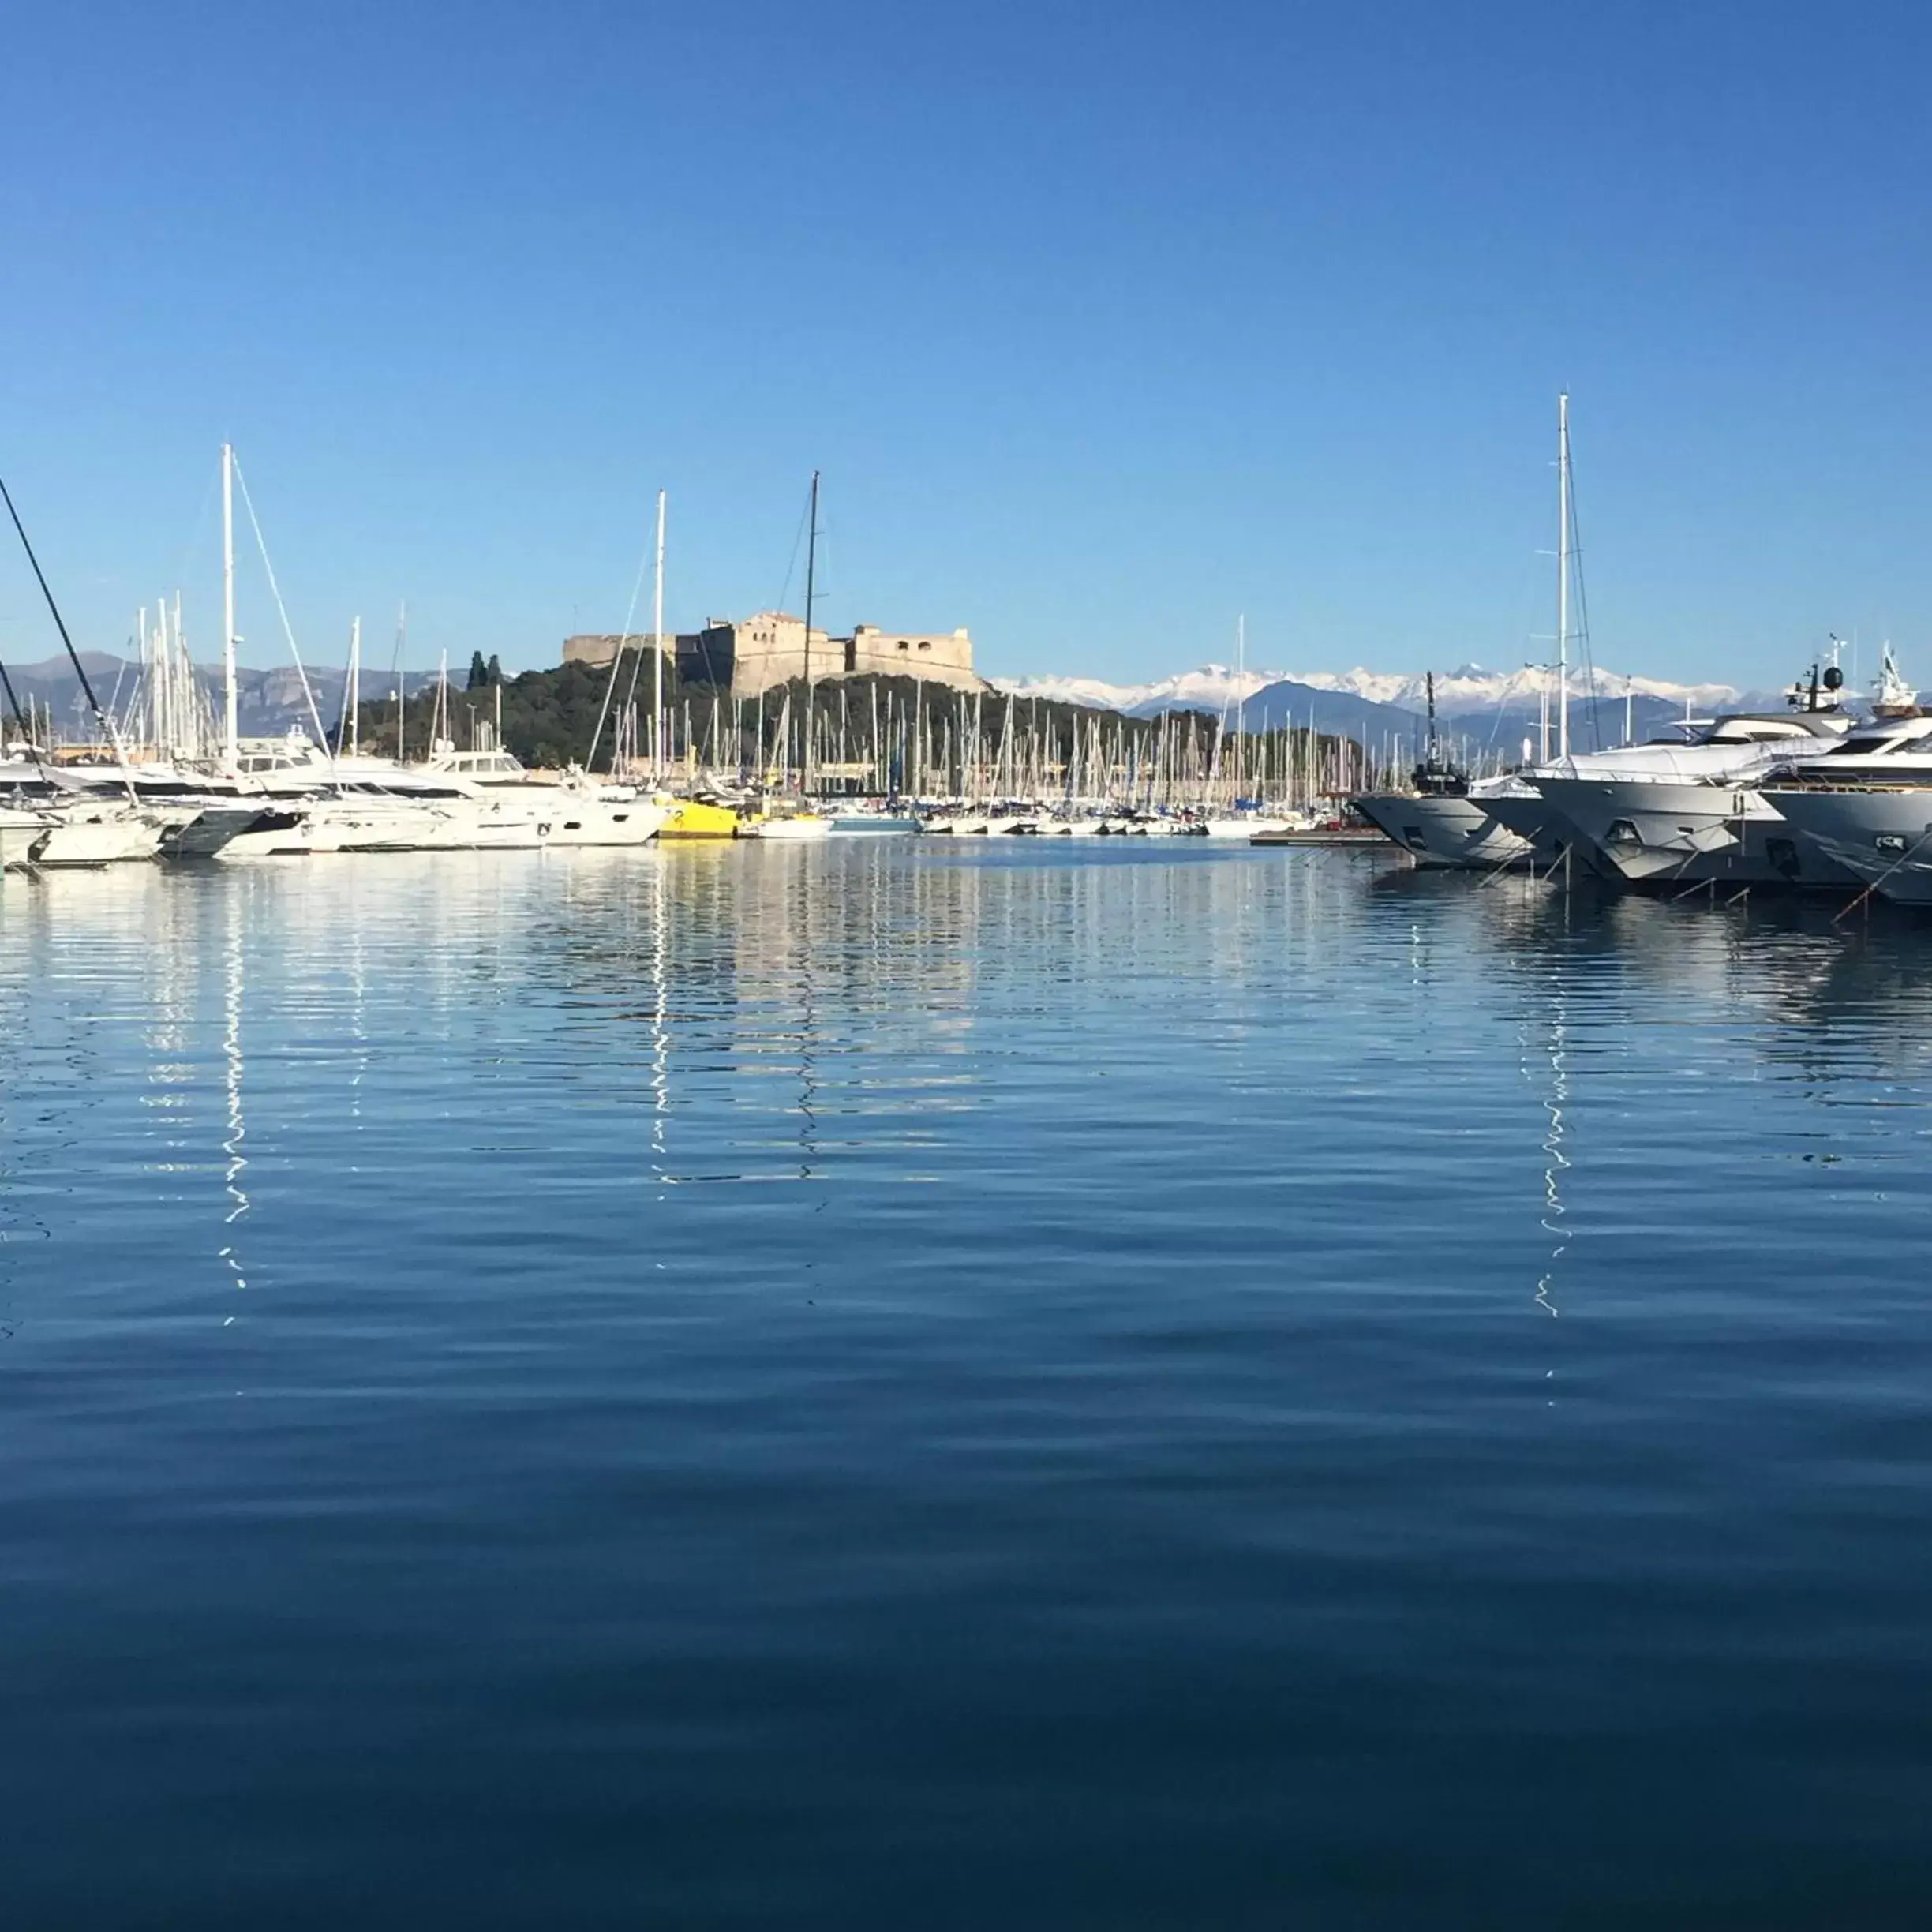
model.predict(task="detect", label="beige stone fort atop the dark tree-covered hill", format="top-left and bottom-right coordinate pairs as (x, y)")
top-left (564, 611), bottom-right (987, 698)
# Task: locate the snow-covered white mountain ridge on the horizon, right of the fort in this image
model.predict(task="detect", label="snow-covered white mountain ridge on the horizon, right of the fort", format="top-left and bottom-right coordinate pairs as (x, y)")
top-left (991, 665), bottom-right (1743, 717)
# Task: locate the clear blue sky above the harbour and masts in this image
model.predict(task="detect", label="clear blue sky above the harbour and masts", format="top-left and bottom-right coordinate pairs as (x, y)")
top-left (0, 0), bottom-right (1932, 684)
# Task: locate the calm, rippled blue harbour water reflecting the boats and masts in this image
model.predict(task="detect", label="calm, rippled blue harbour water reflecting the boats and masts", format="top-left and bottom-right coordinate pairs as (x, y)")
top-left (0, 841), bottom-right (1932, 1932)
